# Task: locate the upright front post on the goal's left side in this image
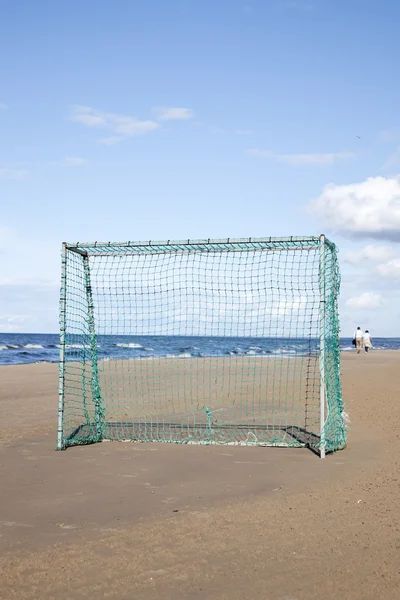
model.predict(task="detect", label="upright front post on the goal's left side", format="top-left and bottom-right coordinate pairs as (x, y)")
top-left (57, 243), bottom-right (67, 450)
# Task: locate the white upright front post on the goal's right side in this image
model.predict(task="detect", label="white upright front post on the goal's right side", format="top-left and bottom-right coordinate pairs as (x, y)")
top-left (319, 235), bottom-right (326, 458)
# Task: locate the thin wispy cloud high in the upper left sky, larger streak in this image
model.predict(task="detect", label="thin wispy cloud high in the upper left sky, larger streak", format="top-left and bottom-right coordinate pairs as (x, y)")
top-left (71, 106), bottom-right (160, 144)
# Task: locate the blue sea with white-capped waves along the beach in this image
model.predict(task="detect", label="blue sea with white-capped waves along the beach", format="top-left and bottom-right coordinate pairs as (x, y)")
top-left (0, 333), bottom-right (400, 365)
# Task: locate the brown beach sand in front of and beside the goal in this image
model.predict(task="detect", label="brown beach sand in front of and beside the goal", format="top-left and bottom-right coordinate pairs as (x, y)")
top-left (0, 352), bottom-right (400, 600)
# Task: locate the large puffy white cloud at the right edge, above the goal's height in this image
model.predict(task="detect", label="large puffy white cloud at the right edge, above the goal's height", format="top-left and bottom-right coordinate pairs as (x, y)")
top-left (309, 176), bottom-right (400, 240)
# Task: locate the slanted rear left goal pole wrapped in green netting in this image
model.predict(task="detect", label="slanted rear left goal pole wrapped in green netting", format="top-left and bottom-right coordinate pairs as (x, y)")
top-left (83, 254), bottom-right (104, 442)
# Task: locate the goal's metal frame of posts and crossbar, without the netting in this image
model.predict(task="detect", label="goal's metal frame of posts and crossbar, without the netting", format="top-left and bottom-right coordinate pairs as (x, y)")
top-left (57, 234), bottom-right (346, 458)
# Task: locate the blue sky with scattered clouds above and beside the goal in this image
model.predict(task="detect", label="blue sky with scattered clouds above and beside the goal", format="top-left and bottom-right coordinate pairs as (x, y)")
top-left (0, 0), bottom-right (400, 335)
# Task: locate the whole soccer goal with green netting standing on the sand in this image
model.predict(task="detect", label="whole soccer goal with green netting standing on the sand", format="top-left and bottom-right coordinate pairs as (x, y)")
top-left (57, 235), bottom-right (346, 457)
